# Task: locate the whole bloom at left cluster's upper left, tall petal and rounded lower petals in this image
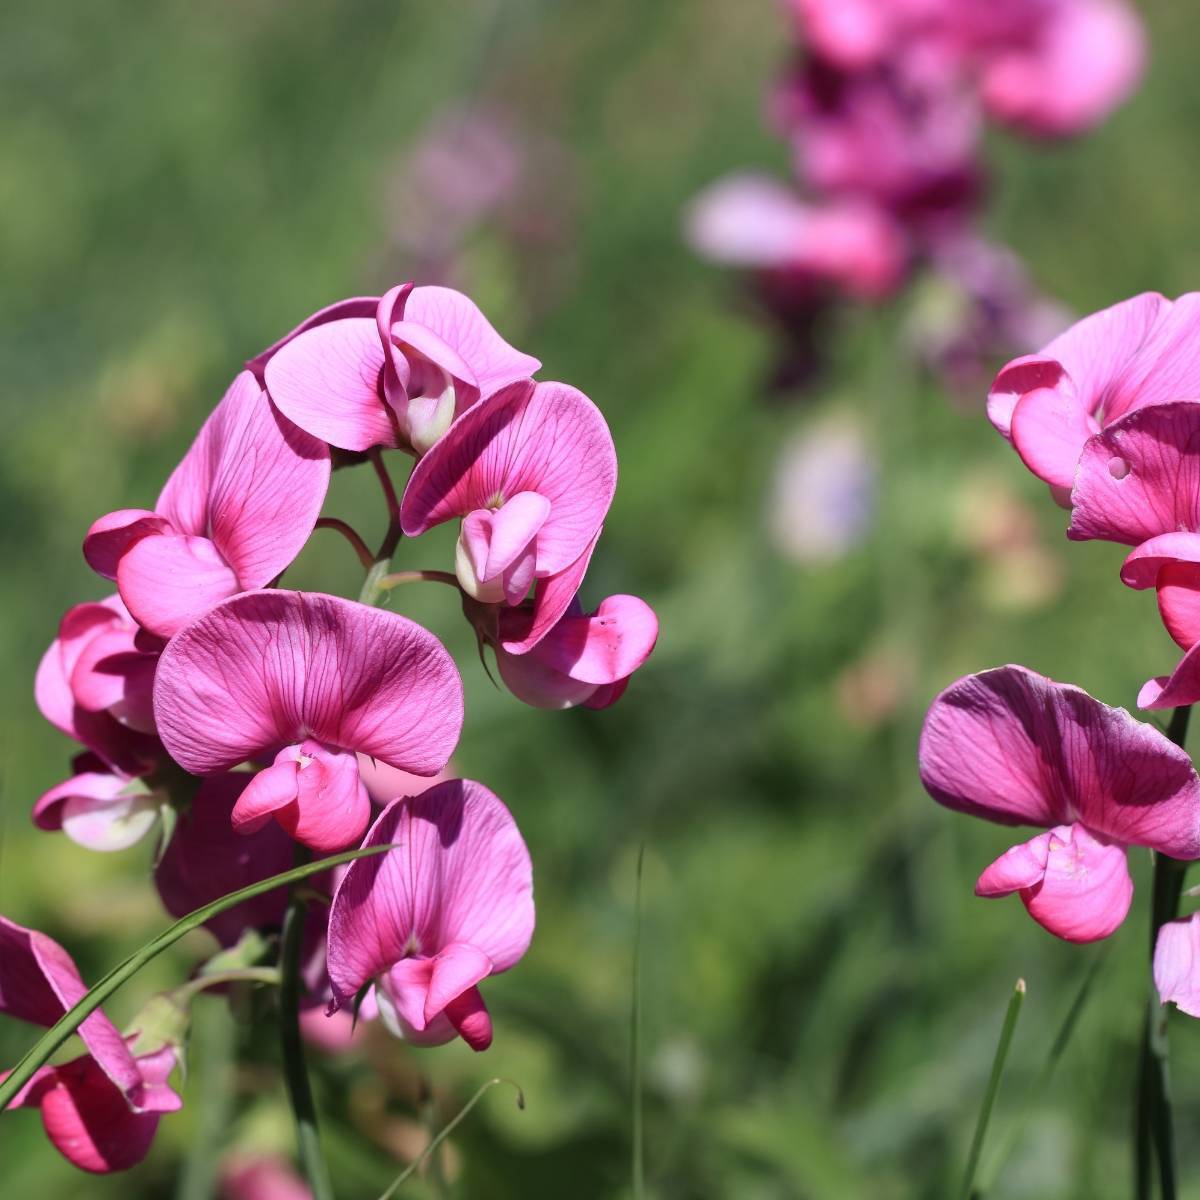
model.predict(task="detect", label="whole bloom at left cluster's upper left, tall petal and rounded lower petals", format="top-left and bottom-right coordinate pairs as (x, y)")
top-left (83, 371), bottom-right (330, 637)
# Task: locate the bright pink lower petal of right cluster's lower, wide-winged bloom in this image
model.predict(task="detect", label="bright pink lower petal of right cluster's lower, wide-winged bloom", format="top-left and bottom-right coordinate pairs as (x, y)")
top-left (976, 824), bottom-right (1133, 942)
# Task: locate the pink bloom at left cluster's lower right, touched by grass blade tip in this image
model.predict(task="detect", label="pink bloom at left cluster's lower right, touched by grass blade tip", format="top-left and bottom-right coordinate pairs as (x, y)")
top-left (329, 780), bottom-right (534, 1050)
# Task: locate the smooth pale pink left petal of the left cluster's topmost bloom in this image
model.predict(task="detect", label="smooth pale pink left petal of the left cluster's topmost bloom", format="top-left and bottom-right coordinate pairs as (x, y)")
top-left (265, 318), bottom-right (396, 450)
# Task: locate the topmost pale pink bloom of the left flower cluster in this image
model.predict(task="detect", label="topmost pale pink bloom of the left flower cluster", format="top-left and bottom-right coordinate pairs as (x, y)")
top-left (268, 283), bottom-right (541, 454)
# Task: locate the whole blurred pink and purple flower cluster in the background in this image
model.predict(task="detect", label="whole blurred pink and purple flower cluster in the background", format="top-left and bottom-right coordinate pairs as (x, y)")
top-left (688, 0), bottom-right (1145, 384)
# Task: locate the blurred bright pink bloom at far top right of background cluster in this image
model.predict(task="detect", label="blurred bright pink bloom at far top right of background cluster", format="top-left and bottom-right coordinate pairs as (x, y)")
top-left (980, 0), bottom-right (1146, 137)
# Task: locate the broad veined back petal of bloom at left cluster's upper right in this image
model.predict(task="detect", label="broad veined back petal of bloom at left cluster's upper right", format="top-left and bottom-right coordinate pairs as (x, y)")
top-left (401, 383), bottom-right (617, 576)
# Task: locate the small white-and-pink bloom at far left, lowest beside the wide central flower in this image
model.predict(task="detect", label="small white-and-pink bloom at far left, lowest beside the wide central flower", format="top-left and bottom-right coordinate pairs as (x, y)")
top-left (32, 751), bottom-right (167, 851)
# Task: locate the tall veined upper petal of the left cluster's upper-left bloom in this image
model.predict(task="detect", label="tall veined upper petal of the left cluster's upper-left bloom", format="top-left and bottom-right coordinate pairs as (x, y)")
top-left (157, 369), bottom-right (332, 589)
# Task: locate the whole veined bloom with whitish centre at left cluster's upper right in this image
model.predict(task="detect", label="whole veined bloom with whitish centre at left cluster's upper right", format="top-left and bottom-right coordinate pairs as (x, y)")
top-left (401, 382), bottom-right (617, 605)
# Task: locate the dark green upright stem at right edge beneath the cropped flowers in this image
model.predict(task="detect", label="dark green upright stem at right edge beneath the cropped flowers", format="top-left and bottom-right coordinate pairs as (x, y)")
top-left (1134, 704), bottom-right (1192, 1200)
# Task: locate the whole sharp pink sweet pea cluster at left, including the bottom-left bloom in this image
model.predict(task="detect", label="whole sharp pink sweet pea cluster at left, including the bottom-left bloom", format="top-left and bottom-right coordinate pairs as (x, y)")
top-left (0, 283), bottom-right (658, 1171)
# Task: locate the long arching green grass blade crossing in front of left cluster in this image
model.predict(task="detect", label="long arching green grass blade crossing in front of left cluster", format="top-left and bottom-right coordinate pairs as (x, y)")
top-left (0, 844), bottom-right (398, 1112)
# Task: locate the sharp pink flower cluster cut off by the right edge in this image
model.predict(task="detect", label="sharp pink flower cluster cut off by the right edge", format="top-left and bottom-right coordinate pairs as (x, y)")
top-left (919, 293), bottom-right (1200, 1016)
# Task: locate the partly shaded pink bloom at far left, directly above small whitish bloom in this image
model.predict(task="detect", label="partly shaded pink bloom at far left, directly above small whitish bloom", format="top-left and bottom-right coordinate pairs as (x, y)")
top-left (34, 596), bottom-right (162, 775)
